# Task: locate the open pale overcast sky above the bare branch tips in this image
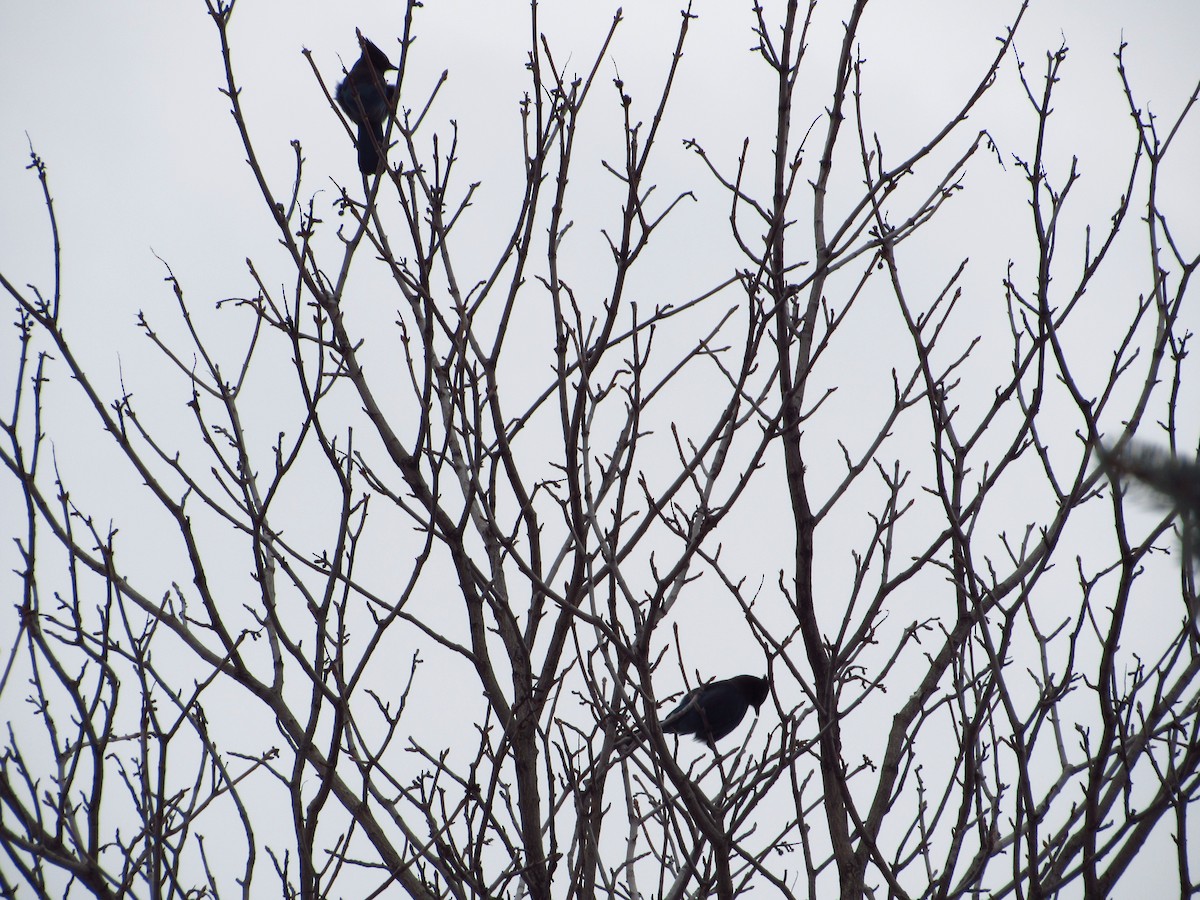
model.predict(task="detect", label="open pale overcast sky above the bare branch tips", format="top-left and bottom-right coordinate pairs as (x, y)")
top-left (0, 0), bottom-right (1200, 374)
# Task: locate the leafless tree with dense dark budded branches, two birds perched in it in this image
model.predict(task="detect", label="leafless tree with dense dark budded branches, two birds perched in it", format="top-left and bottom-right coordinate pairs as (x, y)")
top-left (0, 0), bottom-right (1200, 900)
